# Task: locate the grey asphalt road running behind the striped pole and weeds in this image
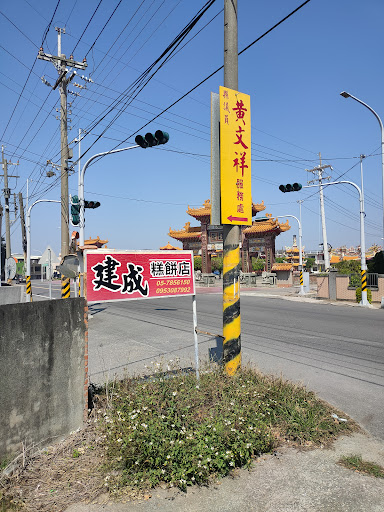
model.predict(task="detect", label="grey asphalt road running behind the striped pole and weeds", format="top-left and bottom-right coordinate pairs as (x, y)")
top-left (89, 294), bottom-right (384, 440)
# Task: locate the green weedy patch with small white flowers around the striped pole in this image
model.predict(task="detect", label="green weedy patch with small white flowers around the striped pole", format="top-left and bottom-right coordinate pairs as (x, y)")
top-left (99, 368), bottom-right (351, 492)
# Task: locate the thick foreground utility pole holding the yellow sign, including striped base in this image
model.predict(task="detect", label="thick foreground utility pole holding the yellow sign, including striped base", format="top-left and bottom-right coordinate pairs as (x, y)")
top-left (223, 0), bottom-right (241, 375)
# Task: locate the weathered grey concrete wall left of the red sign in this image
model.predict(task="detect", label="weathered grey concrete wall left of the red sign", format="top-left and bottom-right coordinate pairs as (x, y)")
top-left (0, 298), bottom-right (88, 459)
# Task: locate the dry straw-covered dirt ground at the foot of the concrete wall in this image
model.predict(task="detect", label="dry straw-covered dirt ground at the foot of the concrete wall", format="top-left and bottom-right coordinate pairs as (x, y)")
top-left (0, 418), bottom-right (105, 512)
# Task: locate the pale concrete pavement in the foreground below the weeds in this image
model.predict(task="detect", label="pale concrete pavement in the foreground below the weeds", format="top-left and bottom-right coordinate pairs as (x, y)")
top-left (65, 434), bottom-right (384, 512)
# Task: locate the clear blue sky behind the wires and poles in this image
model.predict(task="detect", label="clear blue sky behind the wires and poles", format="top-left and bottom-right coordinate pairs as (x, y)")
top-left (0, 0), bottom-right (384, 253)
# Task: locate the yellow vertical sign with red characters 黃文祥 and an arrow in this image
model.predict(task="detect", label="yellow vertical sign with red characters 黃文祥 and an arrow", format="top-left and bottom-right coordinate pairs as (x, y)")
top-left (220, 87), bottom-right (252, 226)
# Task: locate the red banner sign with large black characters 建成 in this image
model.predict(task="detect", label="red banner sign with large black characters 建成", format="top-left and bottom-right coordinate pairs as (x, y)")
top-left (85, 249), bottom-right (195, 302)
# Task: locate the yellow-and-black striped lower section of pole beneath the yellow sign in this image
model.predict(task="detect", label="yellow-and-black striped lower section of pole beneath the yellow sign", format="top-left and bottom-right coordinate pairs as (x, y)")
top-left (223, 225), bottom-right (241, 375)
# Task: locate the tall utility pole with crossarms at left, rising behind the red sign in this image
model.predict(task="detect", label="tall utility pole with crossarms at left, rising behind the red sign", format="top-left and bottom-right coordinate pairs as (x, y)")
top-left (37, 27), bottom-right (87, 258)
